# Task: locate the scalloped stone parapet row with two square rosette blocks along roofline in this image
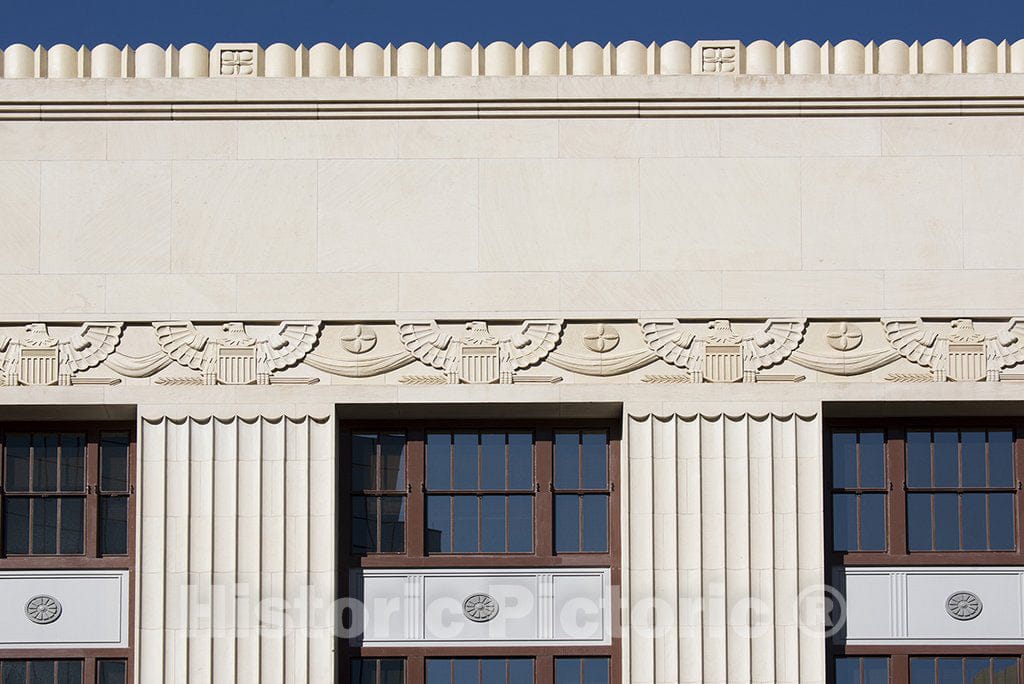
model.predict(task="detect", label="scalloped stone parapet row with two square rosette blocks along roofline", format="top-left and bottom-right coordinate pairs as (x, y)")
top-left (0, 39), bottom-right (1024, 79)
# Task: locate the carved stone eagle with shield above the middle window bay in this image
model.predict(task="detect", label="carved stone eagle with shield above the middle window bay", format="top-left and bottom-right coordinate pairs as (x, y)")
top-left (398, 319), bottom-right (563, 385)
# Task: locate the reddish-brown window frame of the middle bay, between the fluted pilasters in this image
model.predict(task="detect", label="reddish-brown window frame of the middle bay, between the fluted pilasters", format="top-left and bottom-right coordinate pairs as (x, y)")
top-left (336, 419), bottom-right (623, 684)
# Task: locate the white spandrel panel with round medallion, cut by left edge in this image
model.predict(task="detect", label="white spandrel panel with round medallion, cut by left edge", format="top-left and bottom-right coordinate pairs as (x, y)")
top-left (0, 570), bottom-right (128, 648)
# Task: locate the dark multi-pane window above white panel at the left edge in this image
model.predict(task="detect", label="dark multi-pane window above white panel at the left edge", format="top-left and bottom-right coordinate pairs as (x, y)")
top-left (2, 429), bottom-right (132, 559)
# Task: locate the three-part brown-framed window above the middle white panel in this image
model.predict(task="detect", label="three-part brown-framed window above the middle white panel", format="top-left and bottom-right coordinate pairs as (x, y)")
top-left (339, 424), bottom-right (618, 567)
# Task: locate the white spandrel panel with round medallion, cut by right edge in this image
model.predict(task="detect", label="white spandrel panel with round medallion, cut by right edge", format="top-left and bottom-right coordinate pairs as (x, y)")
top-left (840, 567), bottom-right (1024, 645)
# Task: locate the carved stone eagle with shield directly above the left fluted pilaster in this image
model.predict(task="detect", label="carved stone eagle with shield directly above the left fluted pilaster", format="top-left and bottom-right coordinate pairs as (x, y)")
top-left (153, 320), bottom-right (322, 385)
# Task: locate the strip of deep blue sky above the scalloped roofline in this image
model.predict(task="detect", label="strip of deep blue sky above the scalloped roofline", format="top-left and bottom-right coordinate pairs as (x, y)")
top-left (0, 0), bottom-right (1024, 46)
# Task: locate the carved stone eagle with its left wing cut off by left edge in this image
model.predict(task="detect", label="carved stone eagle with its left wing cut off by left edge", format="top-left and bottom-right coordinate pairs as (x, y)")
top-left (0, 323), bottom-right (124, 386)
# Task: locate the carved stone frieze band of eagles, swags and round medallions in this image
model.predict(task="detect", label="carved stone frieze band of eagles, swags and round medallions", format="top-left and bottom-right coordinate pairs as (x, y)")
top-left (0, 317), bottom-right (1024, 387)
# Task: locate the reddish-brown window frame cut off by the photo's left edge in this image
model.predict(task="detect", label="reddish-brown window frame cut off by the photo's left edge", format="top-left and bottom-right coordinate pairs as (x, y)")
top-left (0, 421), bottom-right (138, 684)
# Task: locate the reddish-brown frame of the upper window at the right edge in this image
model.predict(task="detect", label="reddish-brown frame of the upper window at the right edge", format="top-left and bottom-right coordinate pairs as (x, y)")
top-left (822, 417), bottom-right (1024, 567)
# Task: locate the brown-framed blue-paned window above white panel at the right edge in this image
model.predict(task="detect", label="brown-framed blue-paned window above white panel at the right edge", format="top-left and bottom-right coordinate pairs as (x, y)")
top-left (827, 421), bottom-right (1024, 563)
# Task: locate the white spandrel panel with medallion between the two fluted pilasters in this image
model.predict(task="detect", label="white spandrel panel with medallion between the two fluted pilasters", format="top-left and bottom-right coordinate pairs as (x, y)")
top-left (351, 568), bottom-right (611, 646)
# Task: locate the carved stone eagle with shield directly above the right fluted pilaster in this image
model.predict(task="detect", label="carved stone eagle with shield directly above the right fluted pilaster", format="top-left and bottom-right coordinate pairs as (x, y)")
top-left (640, 318), bottom-right (807, 382)
